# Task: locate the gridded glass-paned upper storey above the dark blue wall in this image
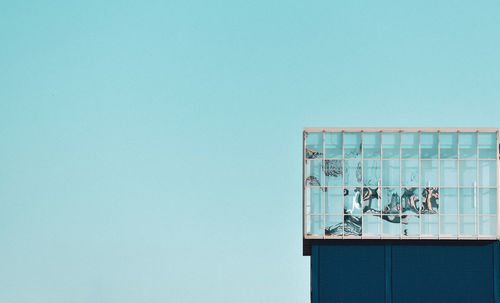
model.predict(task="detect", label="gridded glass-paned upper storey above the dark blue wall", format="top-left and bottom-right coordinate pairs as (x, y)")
top-left (304, 129), bottom-right (498, 239)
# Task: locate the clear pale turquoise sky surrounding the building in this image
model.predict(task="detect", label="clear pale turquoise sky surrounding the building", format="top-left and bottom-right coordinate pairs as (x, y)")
top-left (0, 0), bottom-right (500, 303)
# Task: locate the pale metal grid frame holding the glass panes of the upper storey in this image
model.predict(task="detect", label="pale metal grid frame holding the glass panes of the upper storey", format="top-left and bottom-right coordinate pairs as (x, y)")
top-left (302, 127), bottom-right (500, 240)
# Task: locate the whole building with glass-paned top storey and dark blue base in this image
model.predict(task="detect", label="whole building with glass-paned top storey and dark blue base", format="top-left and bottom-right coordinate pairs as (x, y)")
top-left (303, 128), bottom-right (500, 303)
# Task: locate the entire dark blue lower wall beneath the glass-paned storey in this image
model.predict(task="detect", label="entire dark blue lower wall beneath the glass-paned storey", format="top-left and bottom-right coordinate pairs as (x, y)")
top-left (311, 240), bottom-right (500, 303)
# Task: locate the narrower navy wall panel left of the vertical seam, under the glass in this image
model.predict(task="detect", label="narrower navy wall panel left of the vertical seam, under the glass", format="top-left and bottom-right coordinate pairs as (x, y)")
top-left (313, 244), bottom-right (385, 303)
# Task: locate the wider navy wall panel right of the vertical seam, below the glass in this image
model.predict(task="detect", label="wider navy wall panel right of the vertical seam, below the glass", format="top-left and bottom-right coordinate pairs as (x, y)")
top-left (392, 243), bottom-right (494, 303)
